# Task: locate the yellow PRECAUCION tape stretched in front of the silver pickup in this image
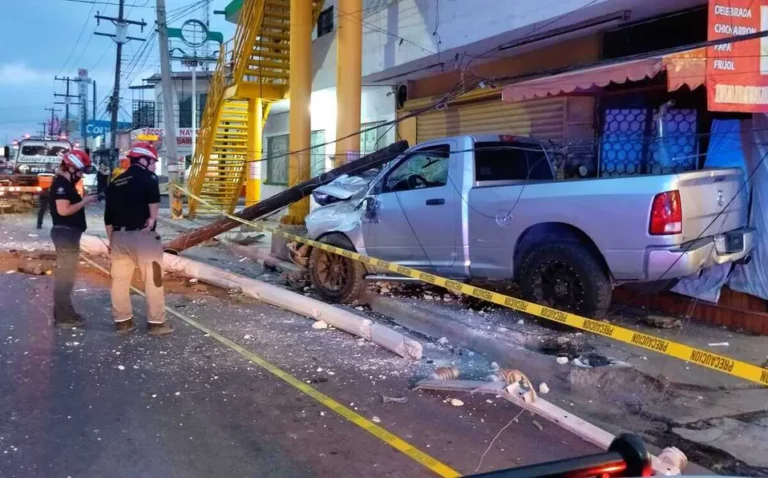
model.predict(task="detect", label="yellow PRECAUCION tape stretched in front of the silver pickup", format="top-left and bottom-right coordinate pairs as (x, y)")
top-left (173, 184), bottom-right (768, 386)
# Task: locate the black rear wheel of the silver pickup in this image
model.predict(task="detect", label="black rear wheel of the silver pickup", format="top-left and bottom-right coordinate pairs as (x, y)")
top-left (518, 242), bottom-right (612, 317)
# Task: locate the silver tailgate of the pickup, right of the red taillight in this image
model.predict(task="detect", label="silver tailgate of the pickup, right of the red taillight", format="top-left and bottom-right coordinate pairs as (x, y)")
top-left (677, 169), bottom-right (748, 242)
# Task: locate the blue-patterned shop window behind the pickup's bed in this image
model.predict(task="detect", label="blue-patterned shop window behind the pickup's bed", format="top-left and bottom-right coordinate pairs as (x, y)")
top-left (600, 107), bottom-right (698, 177)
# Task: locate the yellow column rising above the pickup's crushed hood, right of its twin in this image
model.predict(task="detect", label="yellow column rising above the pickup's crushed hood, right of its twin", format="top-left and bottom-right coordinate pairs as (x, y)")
top-left (334, 0), bottom-right (363, 168)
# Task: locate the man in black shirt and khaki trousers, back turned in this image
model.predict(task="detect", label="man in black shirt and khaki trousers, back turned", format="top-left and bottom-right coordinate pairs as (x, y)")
top-left (104, 142), bottom-right (173, 335)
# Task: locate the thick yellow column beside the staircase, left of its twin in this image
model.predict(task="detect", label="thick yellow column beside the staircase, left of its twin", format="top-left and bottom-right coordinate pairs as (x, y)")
top-left (282, 0), bottom-right (312, 225)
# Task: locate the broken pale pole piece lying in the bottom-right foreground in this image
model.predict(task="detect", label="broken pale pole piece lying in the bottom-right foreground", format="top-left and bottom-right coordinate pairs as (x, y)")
top-left (414, 379), bottom-right (688, 476)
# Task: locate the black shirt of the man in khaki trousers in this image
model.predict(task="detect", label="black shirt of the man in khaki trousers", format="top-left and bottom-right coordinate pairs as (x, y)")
top-left (104, 165), bottom-right (160, 230)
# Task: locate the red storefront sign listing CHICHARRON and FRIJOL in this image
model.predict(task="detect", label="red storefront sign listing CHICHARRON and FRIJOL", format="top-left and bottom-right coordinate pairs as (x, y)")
top-left (707, 0), bottom-right (768, 113)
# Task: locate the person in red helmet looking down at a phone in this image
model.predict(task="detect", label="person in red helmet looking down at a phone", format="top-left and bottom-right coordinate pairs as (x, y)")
top-left (49, 149), bottom-right (97, 328)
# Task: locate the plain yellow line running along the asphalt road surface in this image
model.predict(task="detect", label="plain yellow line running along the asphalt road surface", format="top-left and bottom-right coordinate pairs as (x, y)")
top-left (82, 256), bottom-right (461, 478)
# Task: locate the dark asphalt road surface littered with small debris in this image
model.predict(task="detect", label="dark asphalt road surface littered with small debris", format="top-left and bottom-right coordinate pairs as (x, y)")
top-left (0, 243), bottom-right (597, 477)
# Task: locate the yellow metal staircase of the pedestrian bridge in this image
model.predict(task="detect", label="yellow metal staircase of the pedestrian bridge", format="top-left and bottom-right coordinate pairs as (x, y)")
top-left (189, 0), bottom-right (323, 217)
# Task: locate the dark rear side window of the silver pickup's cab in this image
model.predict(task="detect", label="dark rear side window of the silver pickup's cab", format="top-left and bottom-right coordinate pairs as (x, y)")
top-left (475, 141), bottom-right (554, 182)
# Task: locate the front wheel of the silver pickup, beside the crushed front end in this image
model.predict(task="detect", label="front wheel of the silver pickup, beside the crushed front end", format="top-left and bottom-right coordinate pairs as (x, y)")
top-left (309, 234), bottom-right (366, 304)
